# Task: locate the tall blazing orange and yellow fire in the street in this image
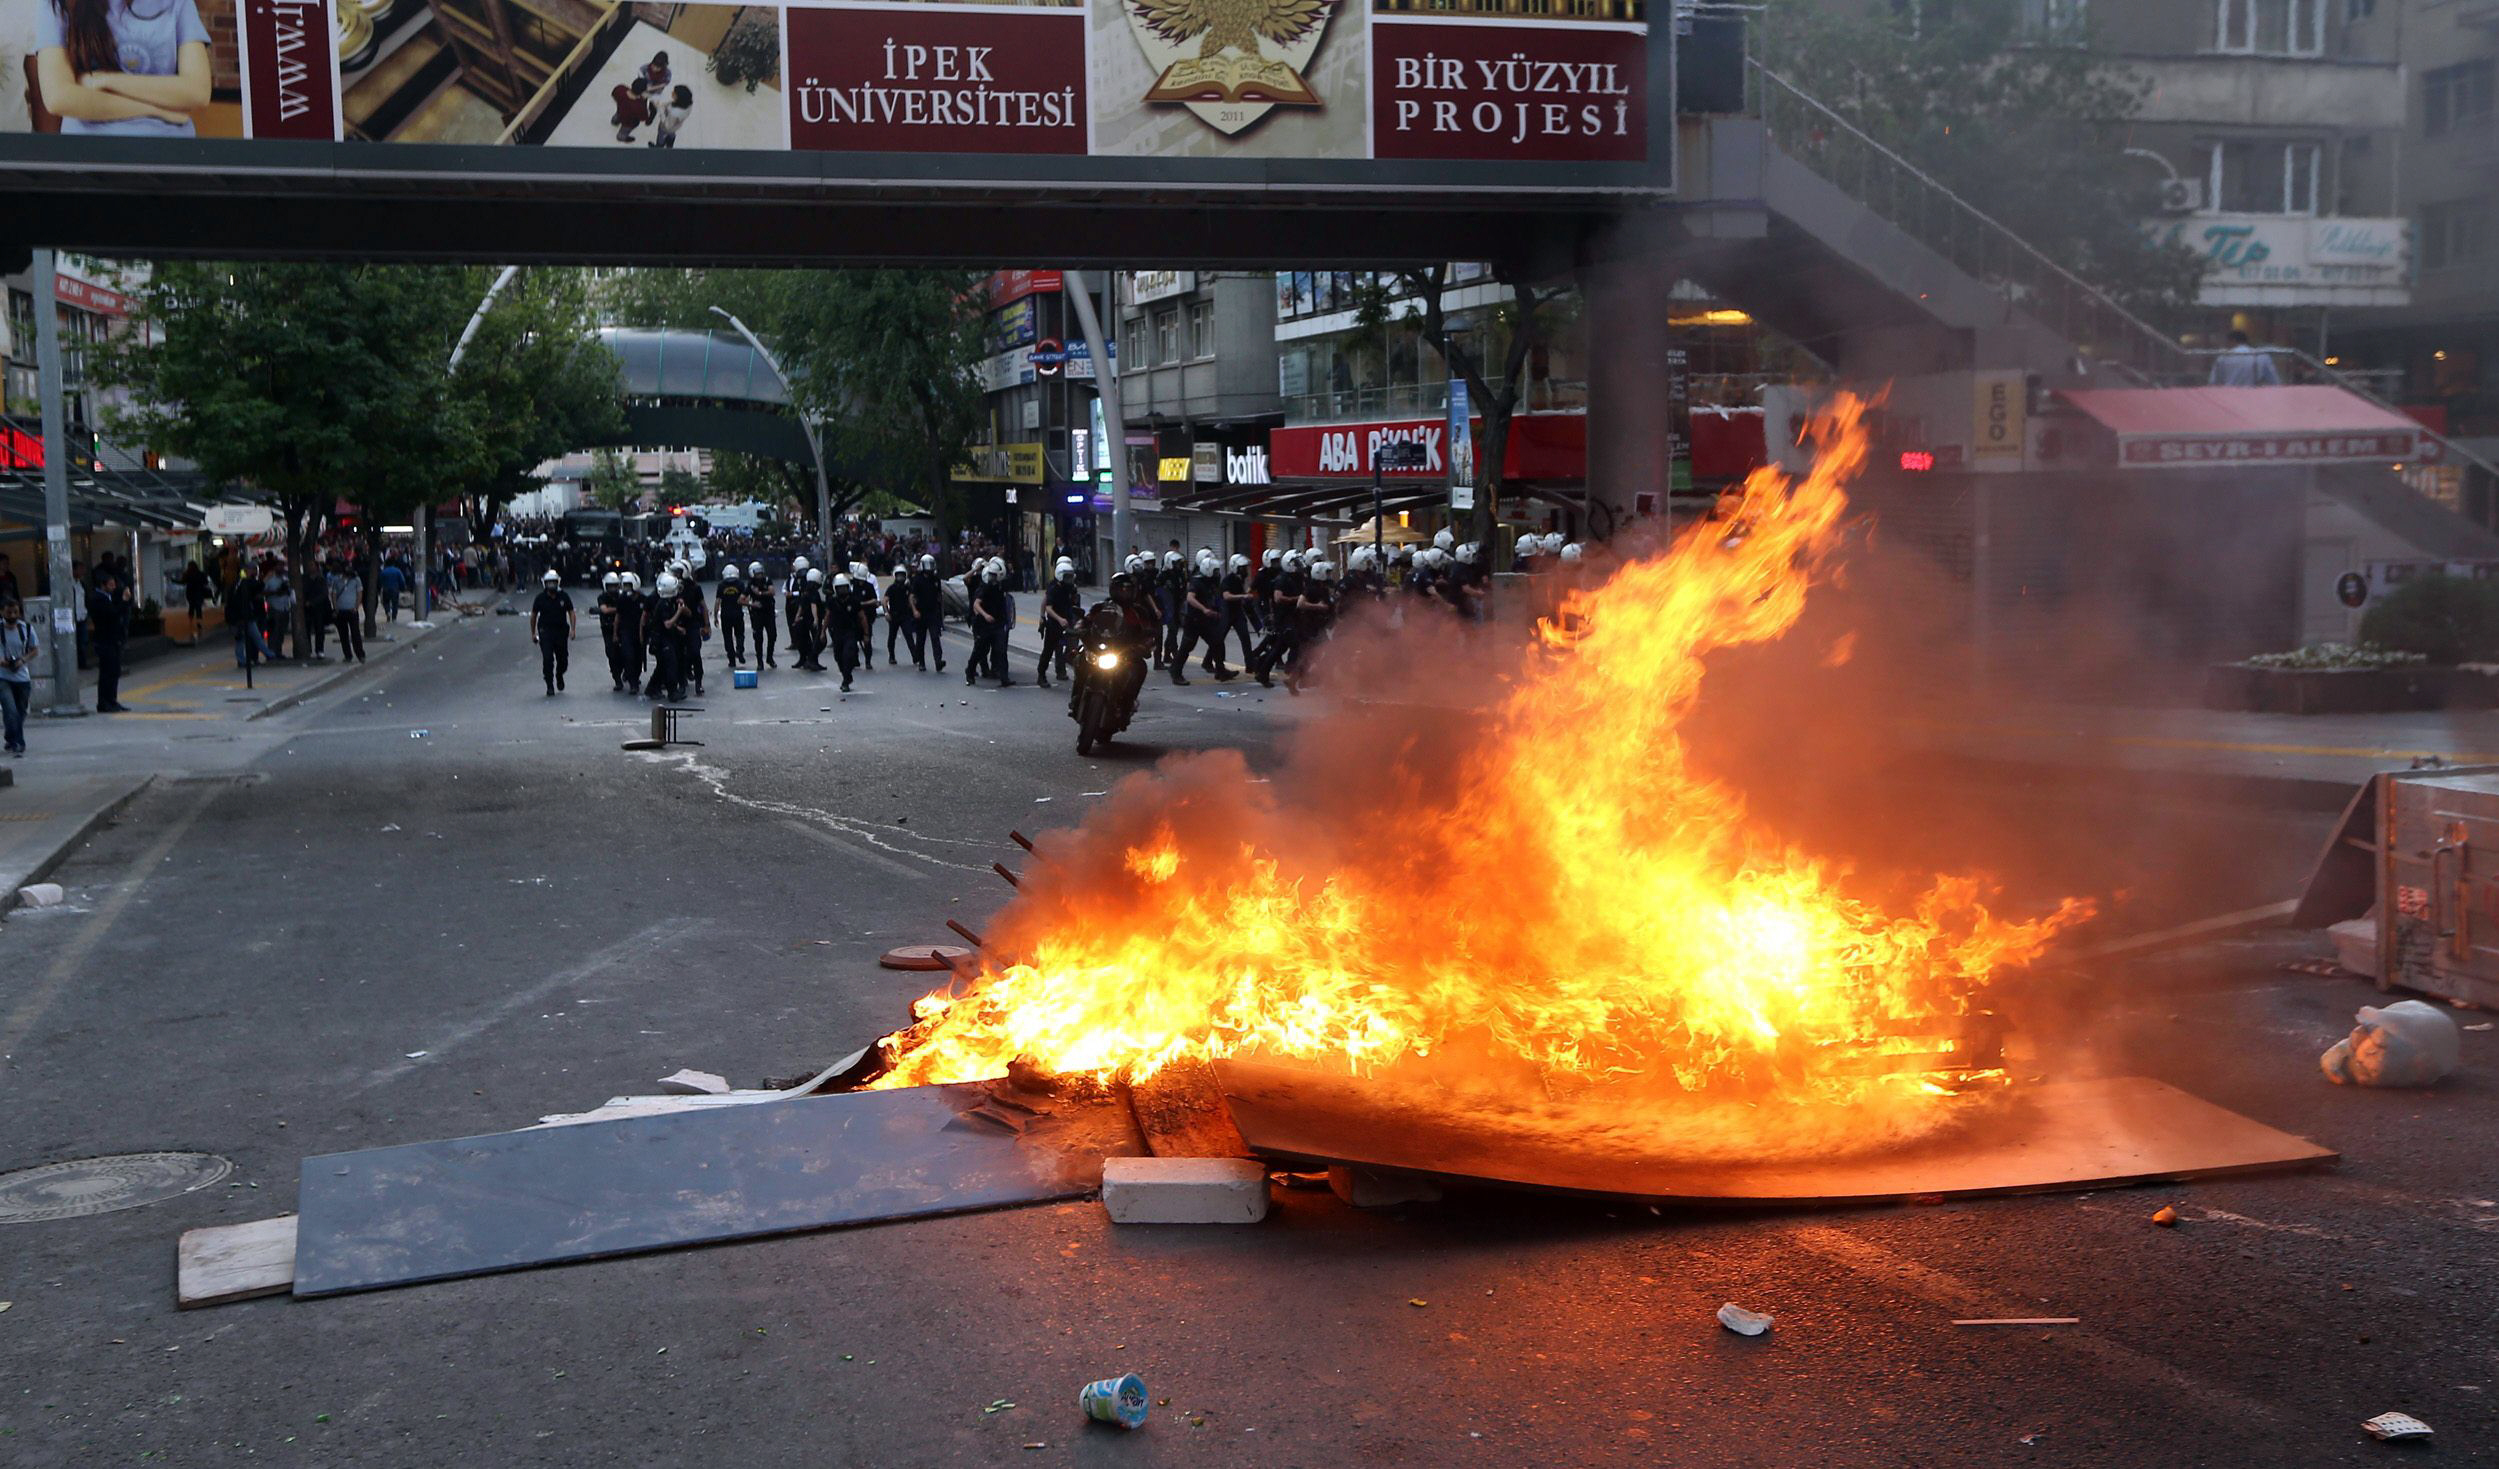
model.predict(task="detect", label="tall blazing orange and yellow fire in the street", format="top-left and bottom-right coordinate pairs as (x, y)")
top-left (877, 400), bottom-right (2087, 1144)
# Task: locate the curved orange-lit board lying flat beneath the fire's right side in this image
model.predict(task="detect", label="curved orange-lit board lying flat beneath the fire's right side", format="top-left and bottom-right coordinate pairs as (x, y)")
top-left (1215, 1059), bottom-right (2334, 1204)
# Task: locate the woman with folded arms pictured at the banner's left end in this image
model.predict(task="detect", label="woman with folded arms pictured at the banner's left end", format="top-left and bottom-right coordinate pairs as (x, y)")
top-left (32, 0), bottom-right (210, 137)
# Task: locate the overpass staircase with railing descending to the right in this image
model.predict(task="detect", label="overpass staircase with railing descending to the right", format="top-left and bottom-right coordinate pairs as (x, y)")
top-left (1677, 57), bottom-right (2499, 497)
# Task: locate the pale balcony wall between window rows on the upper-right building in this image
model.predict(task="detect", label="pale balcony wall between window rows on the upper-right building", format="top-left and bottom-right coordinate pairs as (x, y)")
top-left (2124, 55), bottom-right (2404, 132)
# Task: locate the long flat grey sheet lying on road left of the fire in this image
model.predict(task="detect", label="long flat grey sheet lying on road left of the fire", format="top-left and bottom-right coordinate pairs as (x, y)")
top-left (295, 1084), bottom-right (1142, 1297)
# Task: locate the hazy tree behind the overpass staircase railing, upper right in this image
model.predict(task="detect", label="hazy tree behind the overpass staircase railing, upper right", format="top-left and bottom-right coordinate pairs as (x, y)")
top-left (1762, 0), bottom-right (2202, 312)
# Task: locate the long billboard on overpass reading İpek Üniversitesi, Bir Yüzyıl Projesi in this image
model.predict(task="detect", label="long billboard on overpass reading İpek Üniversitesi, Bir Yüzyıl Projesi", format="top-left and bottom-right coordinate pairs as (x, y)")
top-left (0, 0), bottom-right (1672, 192)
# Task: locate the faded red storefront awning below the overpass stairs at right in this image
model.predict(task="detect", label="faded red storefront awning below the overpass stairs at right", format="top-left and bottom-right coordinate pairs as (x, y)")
top-left (2064, 385), bottom-right (2439, 470)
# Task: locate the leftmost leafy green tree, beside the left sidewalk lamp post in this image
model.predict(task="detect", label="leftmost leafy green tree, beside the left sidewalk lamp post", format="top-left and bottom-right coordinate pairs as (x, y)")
top-left (92, 260), bottom-right (475, 647)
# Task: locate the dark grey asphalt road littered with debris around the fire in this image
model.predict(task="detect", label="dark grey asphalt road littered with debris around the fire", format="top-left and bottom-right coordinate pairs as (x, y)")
top-left (0, 602), bottom-right (2499, 1469)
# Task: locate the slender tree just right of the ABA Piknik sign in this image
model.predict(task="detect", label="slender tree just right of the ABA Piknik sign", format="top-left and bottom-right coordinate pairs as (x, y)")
top-left (1354, 265), bottom-right (1579, 565)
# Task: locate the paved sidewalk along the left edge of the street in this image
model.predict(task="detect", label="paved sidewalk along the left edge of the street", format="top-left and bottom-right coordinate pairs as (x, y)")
top-left (0, 615), bottom-right (457, 912)
